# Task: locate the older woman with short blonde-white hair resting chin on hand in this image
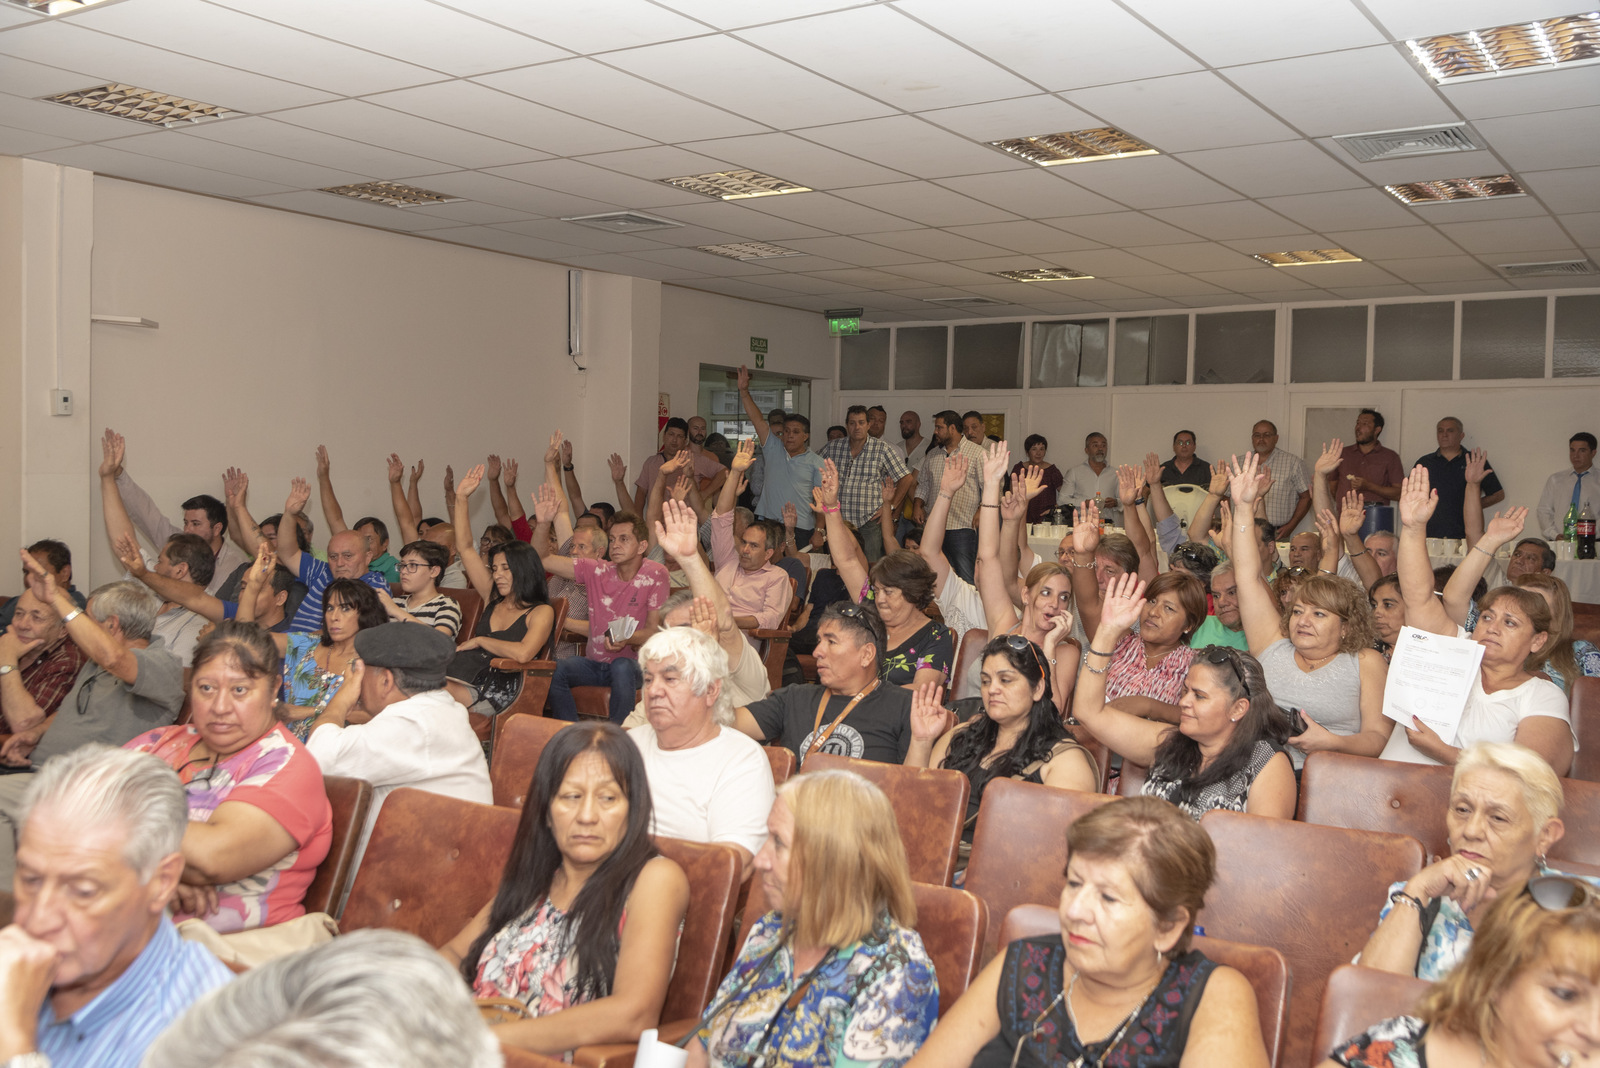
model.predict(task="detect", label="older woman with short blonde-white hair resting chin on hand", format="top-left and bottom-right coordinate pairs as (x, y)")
top-left (1357, 743), bottom-right (1600, 982)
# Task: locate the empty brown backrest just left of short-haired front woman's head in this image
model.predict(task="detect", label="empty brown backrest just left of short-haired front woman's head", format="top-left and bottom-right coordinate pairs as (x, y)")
top-left (962, 779), bottom-right (1115, 956)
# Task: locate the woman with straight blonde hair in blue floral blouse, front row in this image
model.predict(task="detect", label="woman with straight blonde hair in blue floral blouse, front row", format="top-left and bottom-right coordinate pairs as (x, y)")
top-left (688, 771), bottom-right (939, 1068)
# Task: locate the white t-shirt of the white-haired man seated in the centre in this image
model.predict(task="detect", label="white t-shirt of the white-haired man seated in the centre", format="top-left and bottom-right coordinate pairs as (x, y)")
top-left (627, 723), bottom-right (776, 857)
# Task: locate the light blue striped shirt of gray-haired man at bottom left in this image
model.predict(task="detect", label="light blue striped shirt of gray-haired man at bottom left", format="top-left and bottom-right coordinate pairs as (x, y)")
top-left (35, 916), bottom-right (234, 1068)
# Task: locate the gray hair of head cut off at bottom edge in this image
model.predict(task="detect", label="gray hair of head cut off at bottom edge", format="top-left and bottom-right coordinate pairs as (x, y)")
top-left (141, 931), bottom-right (504, 1068)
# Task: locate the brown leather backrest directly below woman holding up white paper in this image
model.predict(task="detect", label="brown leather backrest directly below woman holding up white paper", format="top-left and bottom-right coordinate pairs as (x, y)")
top-left (1294, 753), bottom-right (1451, 857)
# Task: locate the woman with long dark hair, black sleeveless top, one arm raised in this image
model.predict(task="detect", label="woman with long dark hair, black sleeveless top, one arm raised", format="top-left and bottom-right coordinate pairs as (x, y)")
top-left (445, 464), bottom-right (555, 716)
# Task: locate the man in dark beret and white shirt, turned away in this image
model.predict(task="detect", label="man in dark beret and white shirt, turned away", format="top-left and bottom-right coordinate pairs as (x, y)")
top-left (306, 624), bottom-right (494, 888)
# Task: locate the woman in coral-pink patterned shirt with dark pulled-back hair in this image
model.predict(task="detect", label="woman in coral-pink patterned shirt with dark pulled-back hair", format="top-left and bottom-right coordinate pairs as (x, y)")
top-left (126, 617), bottom-right (331, 934)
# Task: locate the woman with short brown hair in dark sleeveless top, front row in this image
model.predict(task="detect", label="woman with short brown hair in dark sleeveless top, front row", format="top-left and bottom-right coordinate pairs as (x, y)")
top-left (910, 798), bottom-right (1267, 1068)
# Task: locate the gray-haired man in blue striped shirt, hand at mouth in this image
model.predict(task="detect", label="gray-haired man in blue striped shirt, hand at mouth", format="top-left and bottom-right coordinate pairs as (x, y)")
top-left (0, 745), bottom-right (232, 1068)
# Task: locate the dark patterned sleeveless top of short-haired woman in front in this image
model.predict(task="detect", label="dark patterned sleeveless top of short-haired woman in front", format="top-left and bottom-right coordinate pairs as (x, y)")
top-left (971, 932), bottom-right (1216, 1068)
